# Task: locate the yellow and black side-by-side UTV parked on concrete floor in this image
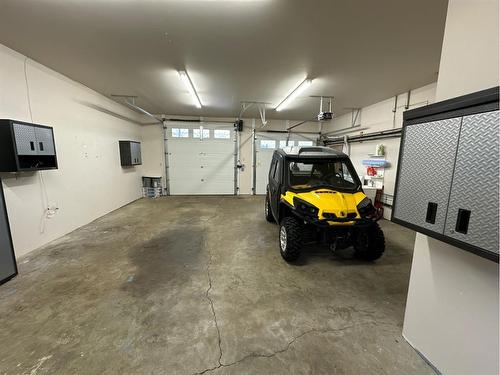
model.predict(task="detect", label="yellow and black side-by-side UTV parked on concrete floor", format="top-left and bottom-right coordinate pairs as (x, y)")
top-left (265, 146), bottom-right (385, 262)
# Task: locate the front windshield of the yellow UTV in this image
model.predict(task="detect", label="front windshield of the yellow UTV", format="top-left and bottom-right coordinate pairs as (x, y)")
top-left (288, 160), bottom-right (360, 191)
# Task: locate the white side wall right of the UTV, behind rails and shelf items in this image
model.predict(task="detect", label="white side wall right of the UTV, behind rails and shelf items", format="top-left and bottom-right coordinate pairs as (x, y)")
top-left (324, 83), bottom-right (436, 219)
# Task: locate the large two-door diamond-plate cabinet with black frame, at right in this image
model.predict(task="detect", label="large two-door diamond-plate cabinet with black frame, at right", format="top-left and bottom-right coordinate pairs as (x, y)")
top-left (392, 87), bottom-right (500, 262)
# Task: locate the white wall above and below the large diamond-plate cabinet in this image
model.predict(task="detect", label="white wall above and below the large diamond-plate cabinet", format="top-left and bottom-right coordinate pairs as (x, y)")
top-left (403, 0), bottom-right (499, 375)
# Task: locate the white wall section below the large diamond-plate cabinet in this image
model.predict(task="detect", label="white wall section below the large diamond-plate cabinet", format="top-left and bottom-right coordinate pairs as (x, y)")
top-left (403, 233), bottom-right (499, 375)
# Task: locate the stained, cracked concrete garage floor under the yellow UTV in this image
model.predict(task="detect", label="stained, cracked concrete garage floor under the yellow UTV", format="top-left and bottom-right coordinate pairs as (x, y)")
top-left (0, 197), bottom-right (433, 375)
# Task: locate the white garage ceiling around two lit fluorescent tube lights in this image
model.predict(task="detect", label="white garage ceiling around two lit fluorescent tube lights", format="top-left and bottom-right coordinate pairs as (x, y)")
top-left (0, 0), bottom-right (447, 119)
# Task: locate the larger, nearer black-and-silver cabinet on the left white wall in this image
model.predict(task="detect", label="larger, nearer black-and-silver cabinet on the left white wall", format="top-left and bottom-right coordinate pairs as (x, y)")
top-left (0, 120), bottom-right (57, 172)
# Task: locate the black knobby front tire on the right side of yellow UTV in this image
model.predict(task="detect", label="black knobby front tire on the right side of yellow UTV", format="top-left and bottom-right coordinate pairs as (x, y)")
top-left (352, 223), bottom-right (385, 261)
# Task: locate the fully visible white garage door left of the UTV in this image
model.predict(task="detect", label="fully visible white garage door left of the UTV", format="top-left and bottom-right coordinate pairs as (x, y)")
top-left (166, 123), bottom-right (235, 195)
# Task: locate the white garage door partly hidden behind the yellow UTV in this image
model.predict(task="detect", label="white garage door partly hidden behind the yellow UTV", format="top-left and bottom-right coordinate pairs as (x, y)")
top-left (255, 132), bottom-right (317, 194)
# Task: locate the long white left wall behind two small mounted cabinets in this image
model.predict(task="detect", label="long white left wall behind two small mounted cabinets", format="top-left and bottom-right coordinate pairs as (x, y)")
top-left (0, 45), bottom-right (148, 257)
